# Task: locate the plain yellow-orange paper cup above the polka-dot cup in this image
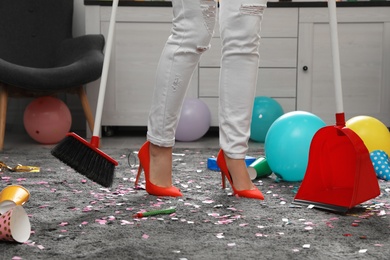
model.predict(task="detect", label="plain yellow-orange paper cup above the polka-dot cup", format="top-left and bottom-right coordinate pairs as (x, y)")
top-left (0, 185), bottom-right (30, 214)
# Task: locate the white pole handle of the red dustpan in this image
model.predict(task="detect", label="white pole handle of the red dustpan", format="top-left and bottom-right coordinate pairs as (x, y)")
top-left (328, 0), bottom-right (344, 114)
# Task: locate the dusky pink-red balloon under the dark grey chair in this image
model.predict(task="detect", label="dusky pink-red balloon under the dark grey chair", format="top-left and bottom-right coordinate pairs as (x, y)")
top-left (23, 96), bottom-right (72, 144)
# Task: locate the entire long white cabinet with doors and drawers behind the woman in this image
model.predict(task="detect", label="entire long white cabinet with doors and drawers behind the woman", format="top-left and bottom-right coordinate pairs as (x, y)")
top-left (86, 5), bottom-right (390, 129)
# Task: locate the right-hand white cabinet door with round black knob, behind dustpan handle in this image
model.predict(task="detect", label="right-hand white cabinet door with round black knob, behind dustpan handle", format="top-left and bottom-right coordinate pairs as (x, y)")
top-left (297, 7), bottom-right (390, 126)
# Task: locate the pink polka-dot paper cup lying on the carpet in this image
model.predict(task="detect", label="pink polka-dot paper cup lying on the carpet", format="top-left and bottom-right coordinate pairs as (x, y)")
top-left (0, 206), bottom-right (31, 243)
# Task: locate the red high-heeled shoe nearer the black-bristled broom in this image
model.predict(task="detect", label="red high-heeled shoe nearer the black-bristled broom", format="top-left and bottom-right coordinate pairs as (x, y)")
top-left (134, 141), bottom-right (183, 197)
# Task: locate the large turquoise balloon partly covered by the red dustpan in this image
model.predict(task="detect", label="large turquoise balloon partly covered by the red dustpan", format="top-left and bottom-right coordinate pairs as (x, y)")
top-left (264, 111), bottom-right (326, 182)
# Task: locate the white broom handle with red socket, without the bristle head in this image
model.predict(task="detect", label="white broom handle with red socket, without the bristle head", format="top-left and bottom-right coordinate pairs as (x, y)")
top-left (91, 0), bottom-right (119, 147)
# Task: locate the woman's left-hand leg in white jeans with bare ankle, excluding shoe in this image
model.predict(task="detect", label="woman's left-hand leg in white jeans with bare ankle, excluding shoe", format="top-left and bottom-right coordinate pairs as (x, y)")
top-left (147, 0), bottom-right (217, 186)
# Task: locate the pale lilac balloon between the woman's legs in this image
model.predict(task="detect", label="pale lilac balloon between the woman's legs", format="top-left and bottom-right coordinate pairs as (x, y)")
top-left (175, 98), bottom-right (211, 142)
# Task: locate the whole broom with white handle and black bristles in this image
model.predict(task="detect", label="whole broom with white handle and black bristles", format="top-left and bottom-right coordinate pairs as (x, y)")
top-left (51, 0), bottom-right (119, 187)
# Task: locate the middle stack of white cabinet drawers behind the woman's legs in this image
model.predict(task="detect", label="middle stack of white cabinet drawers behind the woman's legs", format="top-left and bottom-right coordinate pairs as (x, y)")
top-left (198, 8), bottom-right (298, 126)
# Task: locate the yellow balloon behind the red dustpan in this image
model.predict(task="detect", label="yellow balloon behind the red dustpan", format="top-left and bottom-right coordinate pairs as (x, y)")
top-left (345, 116), bottom-right (390, 154)
